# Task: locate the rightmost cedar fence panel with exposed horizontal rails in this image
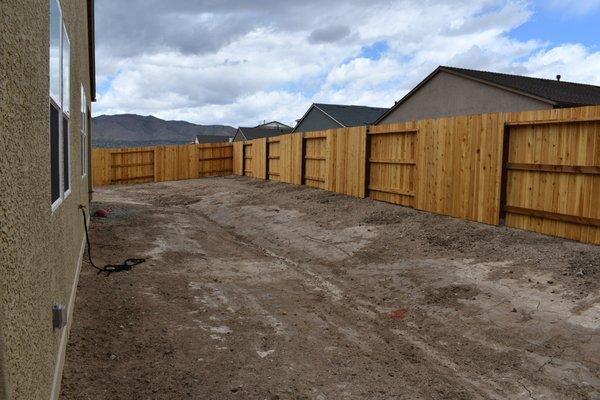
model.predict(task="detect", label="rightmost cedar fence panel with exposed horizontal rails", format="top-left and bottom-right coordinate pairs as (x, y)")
top-left (505, 121), bottom-right (600, 244)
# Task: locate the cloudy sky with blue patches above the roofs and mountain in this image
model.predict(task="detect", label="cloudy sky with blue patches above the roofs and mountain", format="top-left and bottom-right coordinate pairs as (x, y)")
top-left (94, 0), bottom-right (600, 126)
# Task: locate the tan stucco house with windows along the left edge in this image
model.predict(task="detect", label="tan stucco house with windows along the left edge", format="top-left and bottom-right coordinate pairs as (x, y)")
top-left (0, 0), bottom-right (96, 400)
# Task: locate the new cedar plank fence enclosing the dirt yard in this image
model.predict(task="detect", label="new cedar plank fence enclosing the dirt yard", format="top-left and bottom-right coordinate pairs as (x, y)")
top-left (93, 107), bottom-right (600, 244)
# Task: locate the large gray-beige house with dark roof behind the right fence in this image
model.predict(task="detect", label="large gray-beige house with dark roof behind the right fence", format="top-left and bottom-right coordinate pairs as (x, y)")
top-left (376, 66), bottom-right (600, 124)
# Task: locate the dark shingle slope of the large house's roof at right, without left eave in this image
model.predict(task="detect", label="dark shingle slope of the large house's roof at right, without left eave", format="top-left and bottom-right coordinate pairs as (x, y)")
top-left (440, 66), bottom-right (600, 107)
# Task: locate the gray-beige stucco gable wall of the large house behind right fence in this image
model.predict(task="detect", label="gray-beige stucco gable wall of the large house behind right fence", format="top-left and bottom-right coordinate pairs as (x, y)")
top-left (380, 71), bottom-right (552, 124)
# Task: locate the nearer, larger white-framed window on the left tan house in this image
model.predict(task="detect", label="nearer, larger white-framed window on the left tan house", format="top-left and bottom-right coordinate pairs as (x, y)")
top-left (49, 0), bottom-right (71, 210)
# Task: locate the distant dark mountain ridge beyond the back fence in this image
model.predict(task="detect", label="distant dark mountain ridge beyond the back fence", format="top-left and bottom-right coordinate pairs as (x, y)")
top-left (92, 114), bottom-right (236, 147)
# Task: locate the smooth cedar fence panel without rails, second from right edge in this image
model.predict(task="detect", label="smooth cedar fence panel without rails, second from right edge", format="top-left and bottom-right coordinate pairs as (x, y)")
top-left (415, 113), bottom-right (506, 225)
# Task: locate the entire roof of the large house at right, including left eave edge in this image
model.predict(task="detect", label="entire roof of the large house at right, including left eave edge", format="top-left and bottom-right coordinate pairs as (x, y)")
top-left (376, 66), bottom-right (600, 123)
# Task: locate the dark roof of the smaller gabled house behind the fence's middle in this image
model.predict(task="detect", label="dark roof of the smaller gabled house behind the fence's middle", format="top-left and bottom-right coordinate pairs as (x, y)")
top-left (294, 103), bottom-right (387, 131)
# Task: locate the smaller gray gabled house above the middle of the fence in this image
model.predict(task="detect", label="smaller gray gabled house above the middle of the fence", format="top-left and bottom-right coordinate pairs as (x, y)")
top-left (294, 103), bottom-right (387, 132)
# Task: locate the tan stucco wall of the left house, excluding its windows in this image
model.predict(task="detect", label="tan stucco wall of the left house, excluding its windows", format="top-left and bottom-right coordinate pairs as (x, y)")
top-left (0, 0), bottom-right (90, 400)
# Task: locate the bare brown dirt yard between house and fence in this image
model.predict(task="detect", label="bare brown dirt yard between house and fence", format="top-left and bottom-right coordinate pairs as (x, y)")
top-left (62, 177), bottom-right (600, 400)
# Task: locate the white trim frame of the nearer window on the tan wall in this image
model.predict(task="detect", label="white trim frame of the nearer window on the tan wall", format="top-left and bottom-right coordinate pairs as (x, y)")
top-left (48, 0), bottom-right (73, 213)
